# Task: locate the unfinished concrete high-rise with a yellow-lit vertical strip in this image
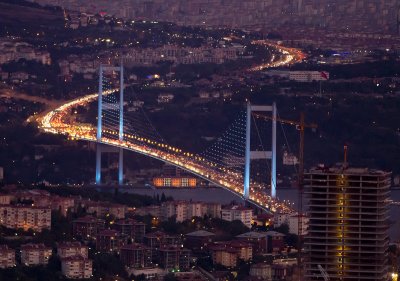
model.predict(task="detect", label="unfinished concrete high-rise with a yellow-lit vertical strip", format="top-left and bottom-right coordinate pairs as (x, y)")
top-left (304, 166), bottom-right (391, 281)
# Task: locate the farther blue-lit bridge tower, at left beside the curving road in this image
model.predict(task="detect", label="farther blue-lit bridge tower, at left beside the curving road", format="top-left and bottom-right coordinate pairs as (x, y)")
top-left (96, 63), bottom-right (124, 185)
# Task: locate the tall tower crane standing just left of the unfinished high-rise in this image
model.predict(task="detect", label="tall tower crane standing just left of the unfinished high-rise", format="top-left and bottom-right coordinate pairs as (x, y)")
top-left (254, 112), bottom-right (318, 280)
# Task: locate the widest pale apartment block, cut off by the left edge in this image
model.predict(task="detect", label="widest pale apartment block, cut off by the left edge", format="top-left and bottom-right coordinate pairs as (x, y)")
top-left (0, 205), bottom-right (51, 231)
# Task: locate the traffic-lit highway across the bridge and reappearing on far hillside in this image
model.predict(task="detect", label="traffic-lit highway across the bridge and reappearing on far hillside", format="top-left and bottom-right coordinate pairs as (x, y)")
top-left (37, 41), bottom-right (304, 213)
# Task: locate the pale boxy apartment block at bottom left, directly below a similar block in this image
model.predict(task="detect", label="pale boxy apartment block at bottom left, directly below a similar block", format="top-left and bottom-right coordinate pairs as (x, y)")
top-left (61, 255), bottom-right (93, 279)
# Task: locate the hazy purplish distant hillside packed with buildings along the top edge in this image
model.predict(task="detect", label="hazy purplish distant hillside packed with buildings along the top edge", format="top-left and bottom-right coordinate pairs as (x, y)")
top-left (33, 0), bottom-right (400, 34)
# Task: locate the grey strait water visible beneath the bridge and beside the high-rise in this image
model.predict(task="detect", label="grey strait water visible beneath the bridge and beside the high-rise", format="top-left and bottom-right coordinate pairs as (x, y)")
top-left (122, 188), bottom-right (400, 241)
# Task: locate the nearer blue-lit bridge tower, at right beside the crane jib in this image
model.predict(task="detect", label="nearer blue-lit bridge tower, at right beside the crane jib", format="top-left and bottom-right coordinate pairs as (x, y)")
top-left (243, 102), bottom-right (277, 199)
